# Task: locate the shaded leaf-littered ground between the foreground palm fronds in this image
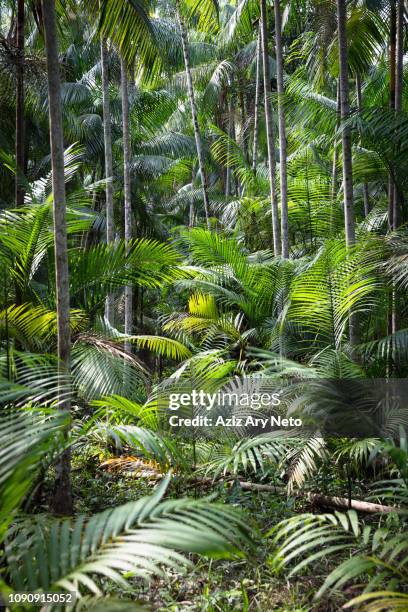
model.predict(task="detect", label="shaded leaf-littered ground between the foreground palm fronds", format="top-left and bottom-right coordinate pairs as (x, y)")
top-left (36, 458), bottom-right (355, 612)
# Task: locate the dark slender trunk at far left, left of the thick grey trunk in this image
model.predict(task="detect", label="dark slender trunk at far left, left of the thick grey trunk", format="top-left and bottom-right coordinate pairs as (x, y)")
top-left (16, 0), bottom-right (25, 206)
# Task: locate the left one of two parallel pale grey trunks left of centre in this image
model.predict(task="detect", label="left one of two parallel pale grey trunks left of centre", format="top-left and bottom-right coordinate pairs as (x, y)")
top-left (101, 38), bottom-right (115, 325)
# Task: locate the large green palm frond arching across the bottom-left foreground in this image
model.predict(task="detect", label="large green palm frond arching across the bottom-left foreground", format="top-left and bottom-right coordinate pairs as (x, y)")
top-left (6, 476), bottom-right (250, 595)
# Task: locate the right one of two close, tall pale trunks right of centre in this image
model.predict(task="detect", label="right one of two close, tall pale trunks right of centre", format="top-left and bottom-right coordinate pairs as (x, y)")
top-left (273, 0), bottom-right (289, 259)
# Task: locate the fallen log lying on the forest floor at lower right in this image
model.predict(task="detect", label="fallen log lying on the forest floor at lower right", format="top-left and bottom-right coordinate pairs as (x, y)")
top-left (239, 481), bottom-right (402, 514)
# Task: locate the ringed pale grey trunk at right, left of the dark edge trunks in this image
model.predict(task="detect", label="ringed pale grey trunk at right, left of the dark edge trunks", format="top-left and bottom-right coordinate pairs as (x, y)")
top-left (337, 0), bottom-right (356, 246)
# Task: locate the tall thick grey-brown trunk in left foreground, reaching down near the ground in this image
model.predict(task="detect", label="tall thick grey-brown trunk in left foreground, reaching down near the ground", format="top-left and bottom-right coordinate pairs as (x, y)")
top-left (42, 0), bottom-right (73, 514)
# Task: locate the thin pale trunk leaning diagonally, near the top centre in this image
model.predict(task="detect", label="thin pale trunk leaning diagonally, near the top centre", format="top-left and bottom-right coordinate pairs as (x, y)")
top-left (176, 1), bottom-right (210, 229)
